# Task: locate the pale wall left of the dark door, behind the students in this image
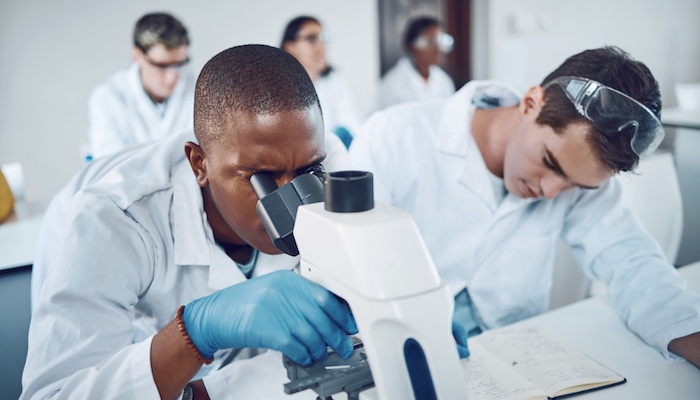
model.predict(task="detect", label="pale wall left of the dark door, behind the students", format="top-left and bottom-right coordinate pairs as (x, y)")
top-left (0, 0), bottom-right (379, 201)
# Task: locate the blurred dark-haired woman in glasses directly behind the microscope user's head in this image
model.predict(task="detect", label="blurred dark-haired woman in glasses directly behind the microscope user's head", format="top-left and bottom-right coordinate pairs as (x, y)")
top-left (280, 16), bottom-right (361, 147)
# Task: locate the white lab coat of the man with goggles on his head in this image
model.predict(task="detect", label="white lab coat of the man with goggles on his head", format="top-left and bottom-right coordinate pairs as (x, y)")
top-left (350, 82), bottom-right (700, 355)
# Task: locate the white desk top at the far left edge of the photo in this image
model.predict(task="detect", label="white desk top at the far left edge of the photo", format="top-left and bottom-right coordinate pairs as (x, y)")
top-left (0, 202), bottom-right (46, 271)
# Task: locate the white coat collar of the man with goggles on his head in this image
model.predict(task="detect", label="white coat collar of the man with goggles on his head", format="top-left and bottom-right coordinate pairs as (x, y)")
top-left (437, 81), bottom-right (521, 211)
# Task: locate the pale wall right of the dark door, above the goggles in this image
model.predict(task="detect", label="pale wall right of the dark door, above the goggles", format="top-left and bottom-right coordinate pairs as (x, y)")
top-left (472, 0), bottom-right (700, 100)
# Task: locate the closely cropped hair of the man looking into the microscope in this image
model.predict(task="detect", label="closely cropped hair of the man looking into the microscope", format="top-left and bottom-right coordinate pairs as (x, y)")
top-left (194, 44), bottom-right (321, 150)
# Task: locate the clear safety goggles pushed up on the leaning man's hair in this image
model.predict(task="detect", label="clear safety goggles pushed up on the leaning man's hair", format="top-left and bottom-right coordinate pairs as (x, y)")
top-left (544, 76), bottom-right (665, 158)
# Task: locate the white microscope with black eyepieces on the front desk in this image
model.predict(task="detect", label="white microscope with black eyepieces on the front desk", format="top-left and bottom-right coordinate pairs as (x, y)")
top-left (251, 171), bottom-right (467, 400)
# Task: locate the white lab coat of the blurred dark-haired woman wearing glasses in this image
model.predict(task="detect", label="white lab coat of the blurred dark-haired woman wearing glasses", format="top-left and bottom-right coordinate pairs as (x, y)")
top-left (314, 69), bottom-right (362, 136)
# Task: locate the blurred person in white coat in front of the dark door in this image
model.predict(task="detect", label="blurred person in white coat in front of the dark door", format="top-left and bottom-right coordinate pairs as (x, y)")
top-left (377, 16), bottom-right (455, 110)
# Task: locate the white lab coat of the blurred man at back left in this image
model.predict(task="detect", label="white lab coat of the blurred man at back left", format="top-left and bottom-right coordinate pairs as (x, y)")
top-left (88, 63), bottom-right (195, 159)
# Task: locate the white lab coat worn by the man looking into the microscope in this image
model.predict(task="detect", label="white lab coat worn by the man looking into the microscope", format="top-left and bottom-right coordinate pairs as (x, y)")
top-left (21, 132), bottom-right (349, 399)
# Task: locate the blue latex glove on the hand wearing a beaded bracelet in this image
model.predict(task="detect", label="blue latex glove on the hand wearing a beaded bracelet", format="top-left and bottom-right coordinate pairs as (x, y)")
top-left (182, 271), bottom-right (357, 365)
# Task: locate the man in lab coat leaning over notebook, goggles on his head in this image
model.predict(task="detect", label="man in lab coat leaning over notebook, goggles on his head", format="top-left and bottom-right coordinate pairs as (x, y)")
top-left (350, 47), bottom-right (700, 367)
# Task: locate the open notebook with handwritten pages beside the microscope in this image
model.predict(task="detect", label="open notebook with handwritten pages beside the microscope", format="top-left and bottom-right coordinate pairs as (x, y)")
top-left (462, 328), bottom-right (626, 400)
